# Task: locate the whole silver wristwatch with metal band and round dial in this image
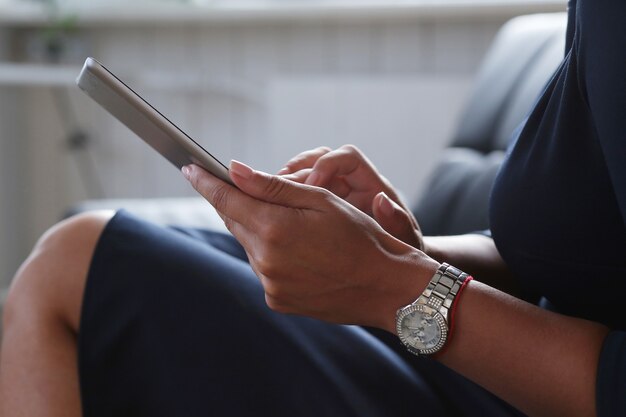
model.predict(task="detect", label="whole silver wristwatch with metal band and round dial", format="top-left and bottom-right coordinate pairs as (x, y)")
top-left (396, 263), bottom-right (471, 356)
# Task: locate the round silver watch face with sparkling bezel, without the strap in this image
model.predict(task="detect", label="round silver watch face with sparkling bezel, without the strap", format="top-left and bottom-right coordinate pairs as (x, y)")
top-left (397, 304), bottom-right (448, 355)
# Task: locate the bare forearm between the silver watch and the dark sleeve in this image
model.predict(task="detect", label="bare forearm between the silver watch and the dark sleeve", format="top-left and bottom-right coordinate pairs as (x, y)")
top-left (439, 282), bottom-right (608, 416)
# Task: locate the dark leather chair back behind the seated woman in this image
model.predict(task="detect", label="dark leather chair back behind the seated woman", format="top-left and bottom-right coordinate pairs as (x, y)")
top-left (414, 13), bottom-right (567, 236)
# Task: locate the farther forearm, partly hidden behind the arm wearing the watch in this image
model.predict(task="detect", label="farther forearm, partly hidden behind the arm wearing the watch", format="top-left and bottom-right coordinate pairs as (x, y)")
top-left (424, 234), bottom-right (520, 295)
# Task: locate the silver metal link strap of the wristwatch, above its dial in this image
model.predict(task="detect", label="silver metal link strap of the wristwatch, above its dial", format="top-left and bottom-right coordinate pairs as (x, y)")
top-left (415, 263), bottom-right (469, 320)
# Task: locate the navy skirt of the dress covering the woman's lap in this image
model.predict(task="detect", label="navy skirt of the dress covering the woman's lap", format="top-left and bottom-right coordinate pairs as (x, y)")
top-left (79, 212), bottom-right (519, 417)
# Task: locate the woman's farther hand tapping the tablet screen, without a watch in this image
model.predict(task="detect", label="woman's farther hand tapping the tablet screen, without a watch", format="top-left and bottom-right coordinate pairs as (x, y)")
top-left (278, 145), bottom-right (424, 250)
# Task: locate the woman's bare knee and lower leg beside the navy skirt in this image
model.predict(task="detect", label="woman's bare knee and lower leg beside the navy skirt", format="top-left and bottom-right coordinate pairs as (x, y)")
top-left (0, 212), bottom-right (113, 417)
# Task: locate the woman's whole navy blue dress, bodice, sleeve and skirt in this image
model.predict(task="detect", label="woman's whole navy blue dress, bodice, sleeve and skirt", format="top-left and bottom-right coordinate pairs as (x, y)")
top-left (79, 0), bottom-right (626, 417)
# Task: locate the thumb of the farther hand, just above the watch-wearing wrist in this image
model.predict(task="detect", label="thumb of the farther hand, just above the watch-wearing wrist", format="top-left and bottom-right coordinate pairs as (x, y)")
top-left (372, 192), bottom-right (419, 246)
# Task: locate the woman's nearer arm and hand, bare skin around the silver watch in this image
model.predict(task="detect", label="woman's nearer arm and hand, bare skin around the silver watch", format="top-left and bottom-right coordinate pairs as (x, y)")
top-left (186, 163), bottom-right (608, 417)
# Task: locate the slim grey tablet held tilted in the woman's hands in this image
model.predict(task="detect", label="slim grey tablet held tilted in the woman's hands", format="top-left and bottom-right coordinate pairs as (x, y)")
top-left (76, 58), bottom-right (234, 185)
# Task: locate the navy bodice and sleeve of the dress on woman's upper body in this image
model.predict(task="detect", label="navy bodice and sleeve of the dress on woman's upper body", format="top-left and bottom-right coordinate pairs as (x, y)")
top-left (490, 0), bottom-right (626, 416)
